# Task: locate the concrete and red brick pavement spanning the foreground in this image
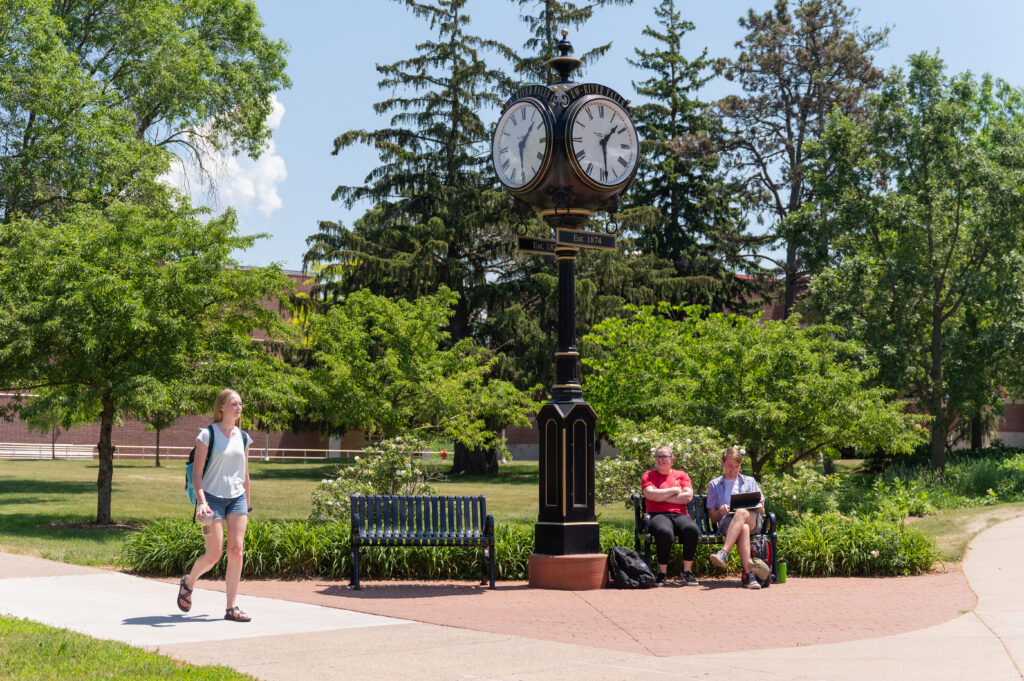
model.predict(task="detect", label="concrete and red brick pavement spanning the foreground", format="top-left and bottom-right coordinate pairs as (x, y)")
top-left (0, 517), bottom-right (1024, 681)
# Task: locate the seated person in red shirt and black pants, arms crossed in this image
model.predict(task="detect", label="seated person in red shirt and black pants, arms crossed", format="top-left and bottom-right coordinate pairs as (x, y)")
top-left (640, 445), bottom-right (700, 587)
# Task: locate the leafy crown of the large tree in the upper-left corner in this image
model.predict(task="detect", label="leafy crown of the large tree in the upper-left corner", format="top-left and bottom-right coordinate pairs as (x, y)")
top-left (0, 0), bottom-right (290, 221)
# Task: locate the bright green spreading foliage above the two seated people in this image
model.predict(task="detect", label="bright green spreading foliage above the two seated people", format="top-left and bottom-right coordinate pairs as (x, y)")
top-left (584, 305), bottom-right (922, 477)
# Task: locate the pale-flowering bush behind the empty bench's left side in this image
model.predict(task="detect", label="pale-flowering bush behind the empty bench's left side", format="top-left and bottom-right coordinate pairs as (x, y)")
top-left (309, 436), bottom-right (442, 522)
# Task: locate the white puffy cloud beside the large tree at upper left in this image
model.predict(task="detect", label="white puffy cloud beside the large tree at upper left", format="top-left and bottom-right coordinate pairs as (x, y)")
top-left (163, 95), bottom-right (288, 216)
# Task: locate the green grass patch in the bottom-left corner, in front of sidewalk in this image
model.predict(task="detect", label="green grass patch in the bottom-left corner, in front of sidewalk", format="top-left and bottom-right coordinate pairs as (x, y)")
top-left (0, 618), bottom-right (255, 681)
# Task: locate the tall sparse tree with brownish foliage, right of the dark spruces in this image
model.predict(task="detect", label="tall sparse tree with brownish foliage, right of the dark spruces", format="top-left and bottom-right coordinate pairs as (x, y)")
top-left (718, 0), bottom-right (888, 315)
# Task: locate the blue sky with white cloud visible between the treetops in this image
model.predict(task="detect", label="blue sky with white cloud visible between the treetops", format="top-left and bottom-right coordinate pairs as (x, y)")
top-left (201, 0), bottom-right (1024, 269)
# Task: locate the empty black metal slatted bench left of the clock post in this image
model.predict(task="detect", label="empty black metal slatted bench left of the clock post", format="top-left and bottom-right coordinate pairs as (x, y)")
top-left (349, 495), bottom-right (495, 589)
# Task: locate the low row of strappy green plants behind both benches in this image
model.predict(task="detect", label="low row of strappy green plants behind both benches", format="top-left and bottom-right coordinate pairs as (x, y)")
top-left (120, 514), bottom-right (936, 580)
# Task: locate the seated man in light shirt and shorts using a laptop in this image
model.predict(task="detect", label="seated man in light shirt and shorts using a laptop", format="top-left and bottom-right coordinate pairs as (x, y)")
top-left (708, 446), bottom-right (765, 589)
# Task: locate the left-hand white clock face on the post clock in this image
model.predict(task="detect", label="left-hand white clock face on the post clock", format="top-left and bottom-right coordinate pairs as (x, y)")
top-left (490, 99), bottom-right (551, 190)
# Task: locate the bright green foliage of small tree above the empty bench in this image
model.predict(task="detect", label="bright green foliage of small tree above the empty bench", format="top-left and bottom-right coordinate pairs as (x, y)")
top-left (307, 287), bottom-right (534, 449)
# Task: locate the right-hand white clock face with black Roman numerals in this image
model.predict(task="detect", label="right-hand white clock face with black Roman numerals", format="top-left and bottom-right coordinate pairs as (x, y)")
top-left (565, 96), bottom-right (640, 188)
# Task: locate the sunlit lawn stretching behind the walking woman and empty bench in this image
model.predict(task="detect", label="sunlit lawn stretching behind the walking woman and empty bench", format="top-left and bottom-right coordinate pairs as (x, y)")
top-left (0, 460), bottom-right (633, 565)
